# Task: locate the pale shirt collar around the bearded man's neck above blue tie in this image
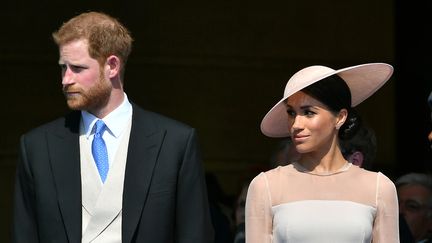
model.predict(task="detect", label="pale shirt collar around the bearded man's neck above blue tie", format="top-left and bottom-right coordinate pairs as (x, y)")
top-left (81, 93), bottom-right (132, 139)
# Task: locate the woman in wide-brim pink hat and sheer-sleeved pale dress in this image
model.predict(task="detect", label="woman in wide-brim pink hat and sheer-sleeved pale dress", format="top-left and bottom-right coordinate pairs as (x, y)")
top-left (246, 63), bottom-right (399, 243)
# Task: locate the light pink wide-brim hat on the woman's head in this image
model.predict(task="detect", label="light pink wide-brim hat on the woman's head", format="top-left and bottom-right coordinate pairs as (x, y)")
top-left (261, 63), bottom-right (393, 137)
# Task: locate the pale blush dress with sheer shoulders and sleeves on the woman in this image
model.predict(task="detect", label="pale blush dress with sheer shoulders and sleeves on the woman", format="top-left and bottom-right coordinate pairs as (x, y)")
top-left (246, 163), bottom-right (399, 243)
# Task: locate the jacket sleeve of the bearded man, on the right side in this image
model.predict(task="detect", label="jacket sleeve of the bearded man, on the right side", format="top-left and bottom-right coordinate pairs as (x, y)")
top-left (176, 129), bottom-right (214, 243)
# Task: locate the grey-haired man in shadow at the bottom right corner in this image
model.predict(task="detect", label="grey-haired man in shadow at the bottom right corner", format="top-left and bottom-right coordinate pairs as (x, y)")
top-left (395, 173), bottom-right (432, 243)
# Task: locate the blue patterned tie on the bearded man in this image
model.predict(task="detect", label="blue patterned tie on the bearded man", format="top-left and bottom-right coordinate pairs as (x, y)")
top-left (92, 120), bottom-right (109, 182)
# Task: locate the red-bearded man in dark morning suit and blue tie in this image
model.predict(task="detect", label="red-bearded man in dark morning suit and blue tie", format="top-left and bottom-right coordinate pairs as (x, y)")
top-left (13, 12), bottom-right (213, 243)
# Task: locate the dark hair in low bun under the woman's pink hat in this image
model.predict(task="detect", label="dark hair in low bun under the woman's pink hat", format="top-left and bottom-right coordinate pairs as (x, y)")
top-left (302, 75), bottom-right (362, 139)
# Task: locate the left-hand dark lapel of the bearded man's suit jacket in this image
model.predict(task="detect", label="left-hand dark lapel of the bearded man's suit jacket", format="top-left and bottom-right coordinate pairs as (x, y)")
top-left (47, 112), bottom-right (82, 242)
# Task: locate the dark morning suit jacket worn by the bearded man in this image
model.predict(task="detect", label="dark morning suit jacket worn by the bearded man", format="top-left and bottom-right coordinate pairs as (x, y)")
top-left (13, 105), bottom-right (213, 243)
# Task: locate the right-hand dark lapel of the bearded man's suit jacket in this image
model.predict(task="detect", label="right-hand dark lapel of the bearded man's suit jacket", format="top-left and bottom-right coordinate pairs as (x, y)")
top-left (122, 105), bottom-right (165, 242)
